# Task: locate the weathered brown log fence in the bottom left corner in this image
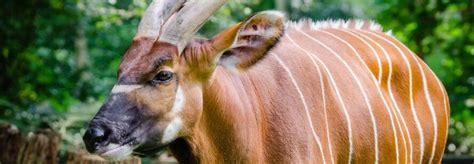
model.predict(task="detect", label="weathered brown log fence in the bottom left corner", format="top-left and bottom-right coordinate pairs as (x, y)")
top-left (0, 123), bottom-right (141, 164)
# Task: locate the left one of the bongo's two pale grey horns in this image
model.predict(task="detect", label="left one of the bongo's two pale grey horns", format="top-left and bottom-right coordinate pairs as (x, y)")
top-left (135, 0), bottom-right (185, 38)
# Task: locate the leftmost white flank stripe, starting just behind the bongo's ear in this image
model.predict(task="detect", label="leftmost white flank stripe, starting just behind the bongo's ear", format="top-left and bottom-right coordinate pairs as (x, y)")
top-left (272, 53), bottom-right (326, 163)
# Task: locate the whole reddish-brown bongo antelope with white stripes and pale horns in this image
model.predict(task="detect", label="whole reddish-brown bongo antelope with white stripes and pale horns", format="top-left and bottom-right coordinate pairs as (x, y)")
top-left (84, 0), bottom-right (450, 164)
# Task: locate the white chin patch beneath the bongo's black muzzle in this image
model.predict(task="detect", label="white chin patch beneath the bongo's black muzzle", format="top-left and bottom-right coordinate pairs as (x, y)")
top-left (99, 143), bottom-right (133, 161)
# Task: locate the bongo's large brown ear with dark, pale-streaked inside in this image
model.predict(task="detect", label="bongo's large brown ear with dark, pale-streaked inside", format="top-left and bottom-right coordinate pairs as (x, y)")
top-left (212, 11), bottom-right (285, 72)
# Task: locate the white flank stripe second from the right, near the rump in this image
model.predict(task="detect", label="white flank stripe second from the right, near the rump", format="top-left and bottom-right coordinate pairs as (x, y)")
top-left (367, 32), bottom-right (425, 162)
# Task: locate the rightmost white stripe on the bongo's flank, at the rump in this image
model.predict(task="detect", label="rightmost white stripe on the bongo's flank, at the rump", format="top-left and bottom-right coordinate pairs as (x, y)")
top-left (396, 41), bottom-right (438, 163)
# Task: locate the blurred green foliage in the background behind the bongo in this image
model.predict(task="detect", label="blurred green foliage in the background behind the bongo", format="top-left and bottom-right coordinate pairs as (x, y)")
top-left (0, 0), bottom-right (474, 155)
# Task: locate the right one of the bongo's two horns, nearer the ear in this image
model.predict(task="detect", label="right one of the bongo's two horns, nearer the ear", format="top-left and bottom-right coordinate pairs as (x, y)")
top-left (158, 0), bottom-right (226, 53)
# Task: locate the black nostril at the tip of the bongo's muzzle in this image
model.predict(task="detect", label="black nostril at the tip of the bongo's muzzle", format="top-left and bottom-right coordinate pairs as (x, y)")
top-left (84, 127), bottom-right (108, 152)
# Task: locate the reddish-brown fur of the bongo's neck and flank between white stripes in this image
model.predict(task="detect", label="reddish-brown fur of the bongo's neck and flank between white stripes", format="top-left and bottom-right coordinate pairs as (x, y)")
top-left (162, 21), bottom-right (449, 163)
